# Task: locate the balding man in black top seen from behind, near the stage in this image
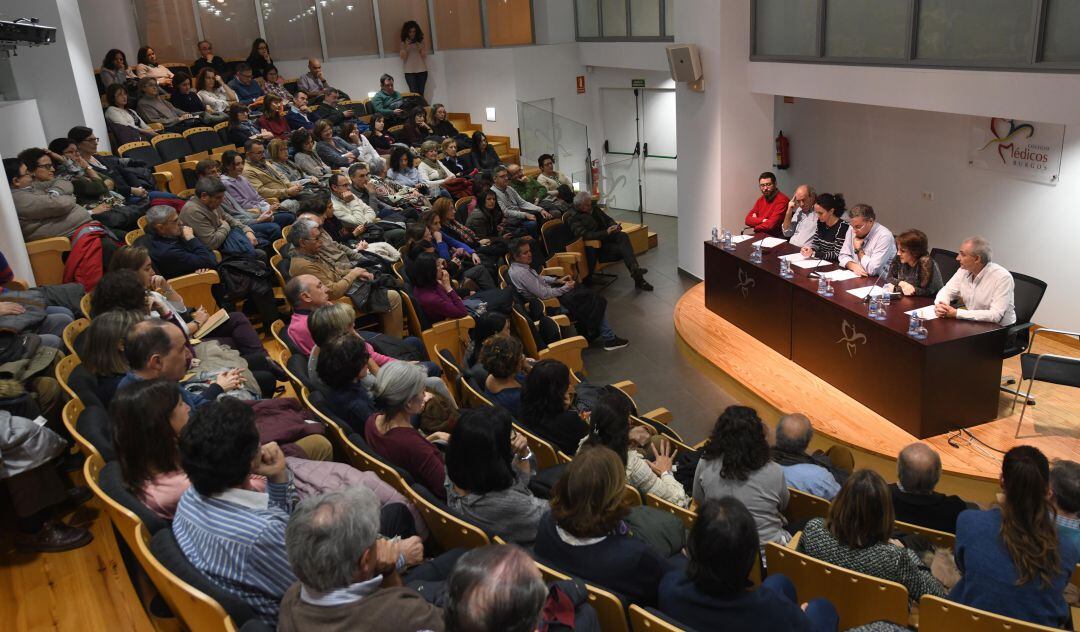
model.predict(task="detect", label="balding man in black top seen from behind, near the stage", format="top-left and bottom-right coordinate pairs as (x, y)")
top-left (889, 443), bottom-right (968, 534)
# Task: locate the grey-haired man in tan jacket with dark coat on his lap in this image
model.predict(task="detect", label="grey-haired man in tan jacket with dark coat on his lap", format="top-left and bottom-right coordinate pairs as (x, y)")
top-left (288, 218), bottom-right (404, 338)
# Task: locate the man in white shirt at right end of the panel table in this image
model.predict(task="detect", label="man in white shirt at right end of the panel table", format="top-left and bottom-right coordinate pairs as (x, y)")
top-left (934, 237), bottom-right (1016, 326)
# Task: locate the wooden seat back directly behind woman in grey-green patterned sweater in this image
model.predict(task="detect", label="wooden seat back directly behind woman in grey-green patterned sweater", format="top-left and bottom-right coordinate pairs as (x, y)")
top-left (765, 542), bottom-right (908, 630)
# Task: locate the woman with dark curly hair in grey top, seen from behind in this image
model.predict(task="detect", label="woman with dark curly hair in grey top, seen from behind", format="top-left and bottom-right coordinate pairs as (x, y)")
top-left (693, 406), bottom-right (792, 547)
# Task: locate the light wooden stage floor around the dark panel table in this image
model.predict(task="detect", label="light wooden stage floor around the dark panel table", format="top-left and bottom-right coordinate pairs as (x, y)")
top-left (675, 283), bottom-right (1080, 483)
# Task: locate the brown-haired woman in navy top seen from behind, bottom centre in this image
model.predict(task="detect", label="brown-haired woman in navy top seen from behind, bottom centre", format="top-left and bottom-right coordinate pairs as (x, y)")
top-left (534, 447), bottom-right (675, 607)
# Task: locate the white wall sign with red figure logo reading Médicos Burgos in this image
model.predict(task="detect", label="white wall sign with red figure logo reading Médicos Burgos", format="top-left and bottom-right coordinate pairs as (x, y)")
top-left (968, 118), bottom-right (1065, 184)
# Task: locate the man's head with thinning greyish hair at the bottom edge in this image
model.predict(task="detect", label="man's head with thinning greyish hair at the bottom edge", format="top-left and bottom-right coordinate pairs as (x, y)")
top-left (444, 544), bottom-right (544, 632)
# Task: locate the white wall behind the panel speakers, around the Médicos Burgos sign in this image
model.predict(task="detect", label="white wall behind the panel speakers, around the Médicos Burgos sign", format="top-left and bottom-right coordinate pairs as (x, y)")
top-left (775, 98), bottom-right (1080, 331)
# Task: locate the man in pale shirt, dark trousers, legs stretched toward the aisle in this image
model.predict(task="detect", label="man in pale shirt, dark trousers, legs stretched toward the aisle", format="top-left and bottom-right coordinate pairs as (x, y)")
top-left (509, 239), bottom-right (630, 351)
